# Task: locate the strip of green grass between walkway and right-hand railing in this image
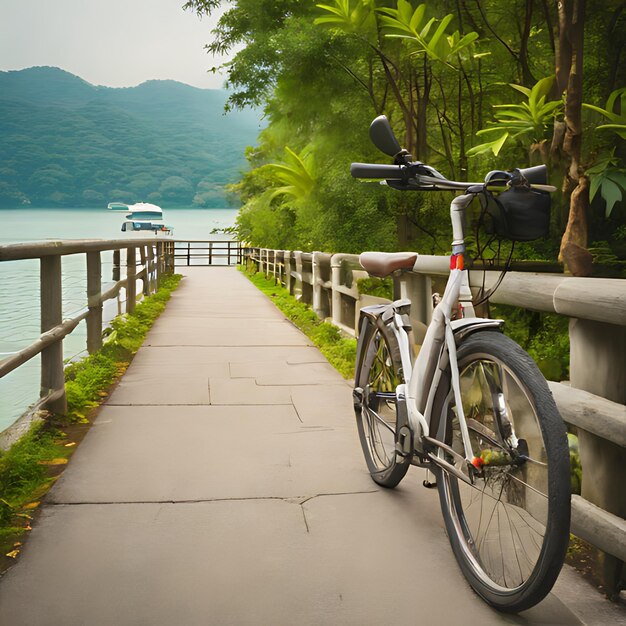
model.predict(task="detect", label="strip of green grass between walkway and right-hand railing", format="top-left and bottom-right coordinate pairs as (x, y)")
top-left (239, 268), bottom-right (356, 378)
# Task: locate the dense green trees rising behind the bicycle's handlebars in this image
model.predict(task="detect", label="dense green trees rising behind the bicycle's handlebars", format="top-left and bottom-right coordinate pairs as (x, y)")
top-left (186, 0), bottom-right (623, 260)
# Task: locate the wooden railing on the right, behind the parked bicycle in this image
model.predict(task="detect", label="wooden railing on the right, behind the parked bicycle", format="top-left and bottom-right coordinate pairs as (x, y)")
top-left (244, 248), bottom-right (626, 561)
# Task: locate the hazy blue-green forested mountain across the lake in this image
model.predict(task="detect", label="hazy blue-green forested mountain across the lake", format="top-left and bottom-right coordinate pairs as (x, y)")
top-left (0, 67), bottom-right (260, 207)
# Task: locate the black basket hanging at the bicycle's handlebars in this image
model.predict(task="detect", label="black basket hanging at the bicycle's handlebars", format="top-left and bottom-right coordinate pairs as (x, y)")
top-left (483, 186), bottom-right (551, 241)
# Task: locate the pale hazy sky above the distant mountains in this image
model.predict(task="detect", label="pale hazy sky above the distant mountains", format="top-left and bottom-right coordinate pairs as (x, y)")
top-left (0, 0), bottom-right (232, 88)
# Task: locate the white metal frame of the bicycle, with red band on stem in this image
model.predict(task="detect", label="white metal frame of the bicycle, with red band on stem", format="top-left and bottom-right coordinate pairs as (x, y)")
top-left (390, 194), bottom-right (502, 482)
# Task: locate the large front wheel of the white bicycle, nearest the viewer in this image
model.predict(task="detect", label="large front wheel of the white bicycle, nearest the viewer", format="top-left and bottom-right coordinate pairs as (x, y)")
top-left (436, 331), bottom-right (570, 612)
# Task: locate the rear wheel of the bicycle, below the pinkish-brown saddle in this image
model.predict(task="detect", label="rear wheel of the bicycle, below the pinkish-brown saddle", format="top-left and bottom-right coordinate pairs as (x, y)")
top-left (354, 325), bottom-right (411, 489)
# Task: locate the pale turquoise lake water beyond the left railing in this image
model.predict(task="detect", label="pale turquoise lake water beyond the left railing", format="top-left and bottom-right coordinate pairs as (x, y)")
top-left (0, 209), bottom-right (237, 431)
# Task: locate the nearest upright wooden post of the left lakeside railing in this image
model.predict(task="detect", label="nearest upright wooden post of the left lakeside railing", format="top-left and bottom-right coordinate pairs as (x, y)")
top-left (40, 255), bottom-right (67, 413)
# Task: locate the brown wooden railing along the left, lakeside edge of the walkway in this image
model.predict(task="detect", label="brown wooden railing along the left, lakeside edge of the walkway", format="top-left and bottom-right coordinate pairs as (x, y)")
top-left (0, 238), bottom-right (174, 438)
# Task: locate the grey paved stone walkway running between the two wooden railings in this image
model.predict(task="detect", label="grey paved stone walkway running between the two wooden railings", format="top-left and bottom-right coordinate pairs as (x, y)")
top-left (0, 268), bottom-right (617, 626)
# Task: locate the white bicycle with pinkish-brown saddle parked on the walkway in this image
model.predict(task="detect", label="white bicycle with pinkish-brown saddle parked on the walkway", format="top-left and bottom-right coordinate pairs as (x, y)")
top-left (351, 116), bottom-right (570, 612)
